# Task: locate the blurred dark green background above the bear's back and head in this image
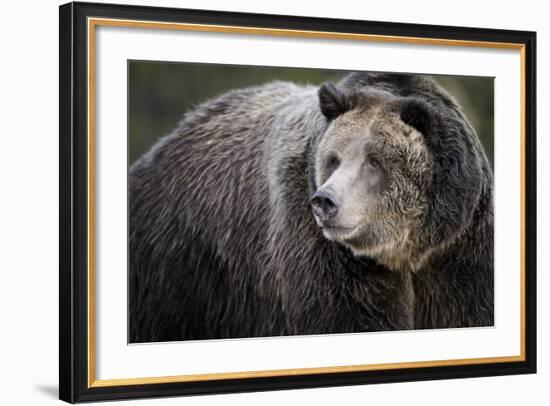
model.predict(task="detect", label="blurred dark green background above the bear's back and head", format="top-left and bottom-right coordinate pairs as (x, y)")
top-left (128, 61), bottom-right (494, 164)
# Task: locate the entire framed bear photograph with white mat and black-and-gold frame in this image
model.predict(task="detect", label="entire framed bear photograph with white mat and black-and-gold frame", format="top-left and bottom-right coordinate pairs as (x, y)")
top-left (60, 3), bottom-right (536, 403)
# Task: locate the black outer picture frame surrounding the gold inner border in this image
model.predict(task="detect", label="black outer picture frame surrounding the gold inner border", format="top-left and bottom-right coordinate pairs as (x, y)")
top-left (59, 3), bottom-right (536, 403)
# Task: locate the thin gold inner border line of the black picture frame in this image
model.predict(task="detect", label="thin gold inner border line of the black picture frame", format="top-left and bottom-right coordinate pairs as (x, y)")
top-left (87, 18), bottom-right (526, 388)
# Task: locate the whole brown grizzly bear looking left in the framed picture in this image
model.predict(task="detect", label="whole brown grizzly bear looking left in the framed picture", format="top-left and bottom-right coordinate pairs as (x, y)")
top-left (129, 73), bottom-right (493, 342)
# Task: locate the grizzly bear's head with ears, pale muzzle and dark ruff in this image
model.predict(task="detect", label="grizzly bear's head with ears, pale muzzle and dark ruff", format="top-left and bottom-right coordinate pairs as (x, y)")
top-left (311, 77), bottom-right (483, 270)
